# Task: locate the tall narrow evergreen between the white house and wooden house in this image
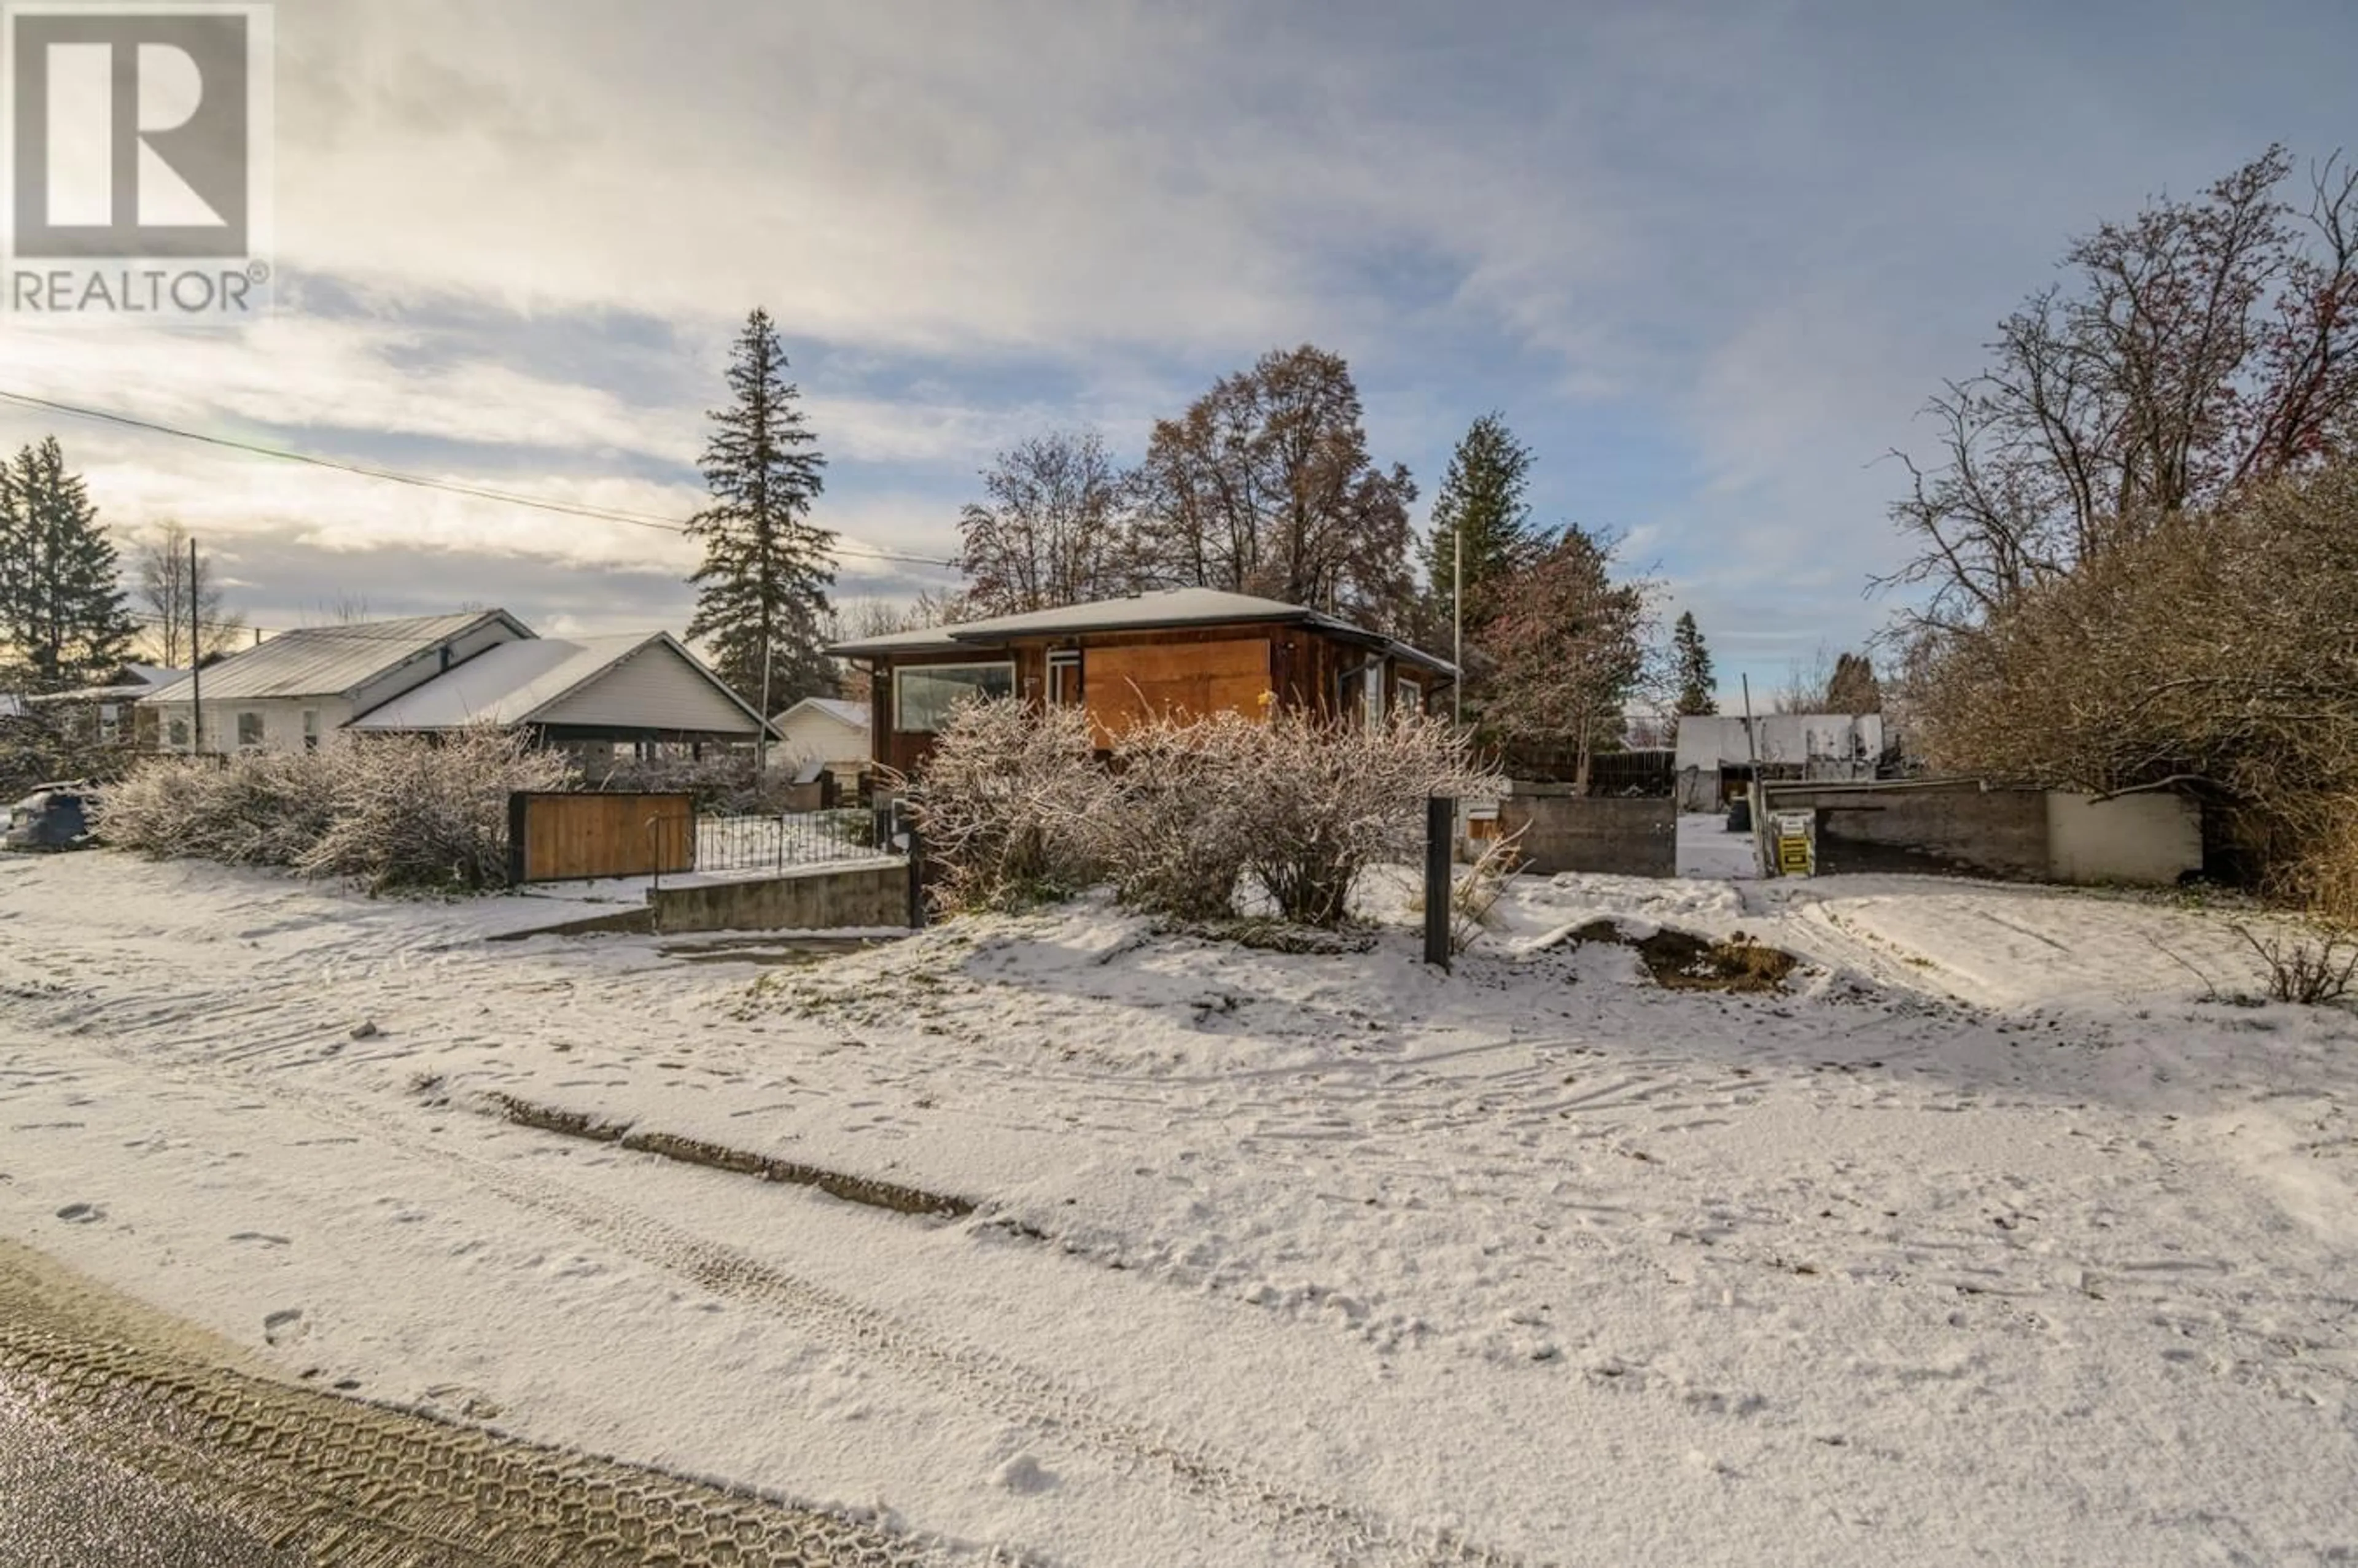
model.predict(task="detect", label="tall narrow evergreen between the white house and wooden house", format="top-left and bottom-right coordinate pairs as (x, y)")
top-left (688, 309), bottom-right (837, 715)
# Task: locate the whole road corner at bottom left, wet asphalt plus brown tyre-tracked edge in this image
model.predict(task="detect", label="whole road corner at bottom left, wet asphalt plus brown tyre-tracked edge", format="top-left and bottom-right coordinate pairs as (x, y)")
top-left (0, 1240), bottom-right (951, 1568)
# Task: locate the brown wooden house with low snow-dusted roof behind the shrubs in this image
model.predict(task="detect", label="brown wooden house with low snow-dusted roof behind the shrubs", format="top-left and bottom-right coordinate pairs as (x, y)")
top-left (828, 587), bottom-right (1457, 774)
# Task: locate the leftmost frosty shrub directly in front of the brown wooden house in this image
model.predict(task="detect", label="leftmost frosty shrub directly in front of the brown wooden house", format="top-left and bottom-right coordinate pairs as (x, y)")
top-left (910, 698), bottom-right (1111, 912)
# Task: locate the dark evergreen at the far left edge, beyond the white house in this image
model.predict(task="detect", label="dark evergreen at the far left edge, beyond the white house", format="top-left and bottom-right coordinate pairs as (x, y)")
top-left (0, 437), bottom-right (137, 691)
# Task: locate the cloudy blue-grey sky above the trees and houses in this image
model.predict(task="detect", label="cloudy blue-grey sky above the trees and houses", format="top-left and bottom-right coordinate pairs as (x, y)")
top-left (0, 0), bottom-right (2358, 688)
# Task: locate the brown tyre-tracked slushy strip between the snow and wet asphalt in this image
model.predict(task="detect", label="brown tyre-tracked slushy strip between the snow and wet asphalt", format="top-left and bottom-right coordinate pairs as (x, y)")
top-left (0, 1311), bottom-right (967, 1568)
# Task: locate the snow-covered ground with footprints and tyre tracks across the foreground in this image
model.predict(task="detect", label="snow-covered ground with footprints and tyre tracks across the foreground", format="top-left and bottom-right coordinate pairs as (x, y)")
top-left (0, 835), bottom-right (2358, 1566)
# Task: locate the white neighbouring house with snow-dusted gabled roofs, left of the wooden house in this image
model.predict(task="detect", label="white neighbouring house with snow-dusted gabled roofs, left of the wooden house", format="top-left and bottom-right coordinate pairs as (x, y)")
top-left (146, 611), bottom-right (764, 757)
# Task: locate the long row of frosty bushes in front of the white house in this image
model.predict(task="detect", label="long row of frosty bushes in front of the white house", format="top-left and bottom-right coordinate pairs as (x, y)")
top-left (96, 731), bottom-right (573, 891)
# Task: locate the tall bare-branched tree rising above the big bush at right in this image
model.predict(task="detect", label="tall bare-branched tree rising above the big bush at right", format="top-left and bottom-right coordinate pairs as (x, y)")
top-left (1881, 146), bottom-right (2358, 627)
